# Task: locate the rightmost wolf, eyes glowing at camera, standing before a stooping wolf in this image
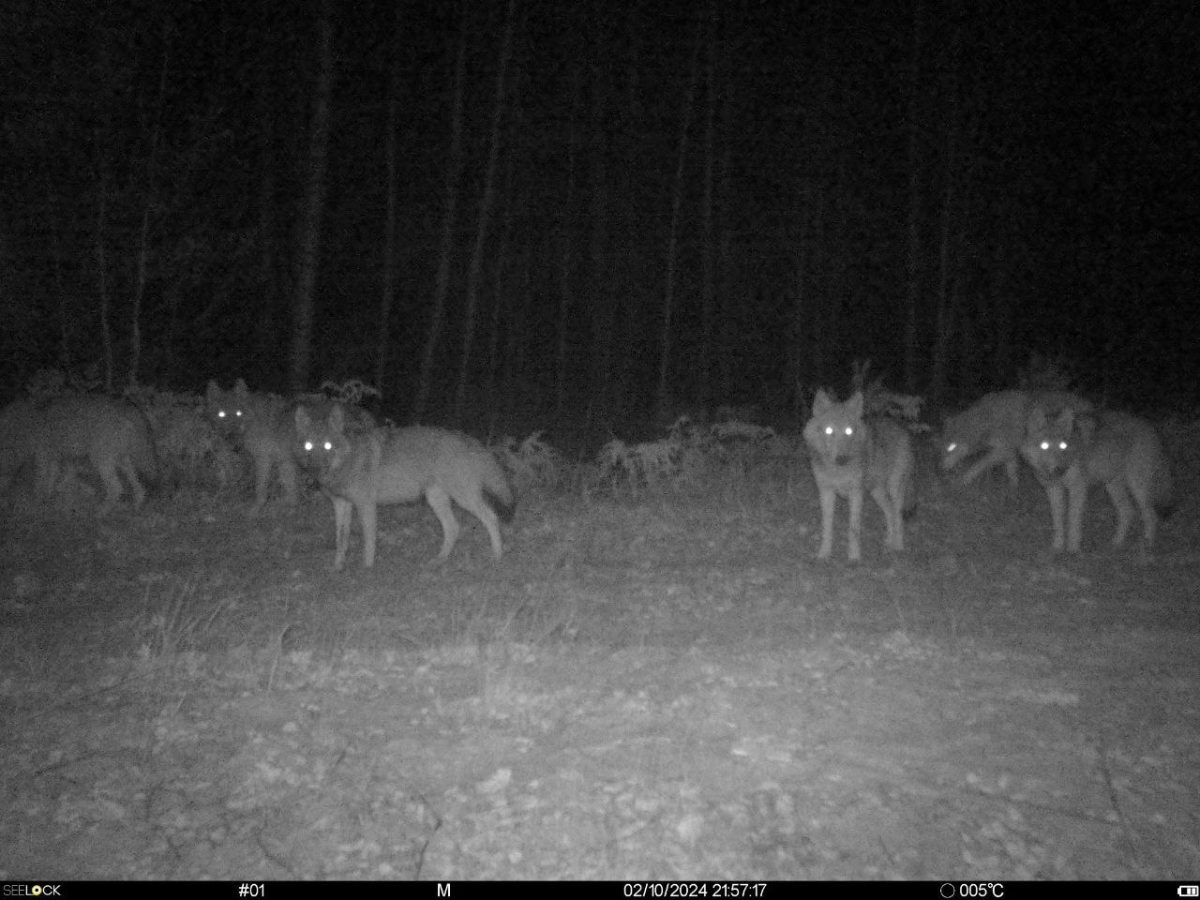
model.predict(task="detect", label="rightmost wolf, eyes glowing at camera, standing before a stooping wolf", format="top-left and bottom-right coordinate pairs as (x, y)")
top-left (1021, 404), bottom-right (1171, 553)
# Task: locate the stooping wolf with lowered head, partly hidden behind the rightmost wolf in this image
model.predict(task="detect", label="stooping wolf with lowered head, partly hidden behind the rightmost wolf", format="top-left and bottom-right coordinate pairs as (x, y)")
top-left (940, 390), bottom-right (1092, 490)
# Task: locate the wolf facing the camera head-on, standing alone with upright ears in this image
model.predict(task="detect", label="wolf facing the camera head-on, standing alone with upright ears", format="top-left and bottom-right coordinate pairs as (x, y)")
top-left (804, 390), bottom-right (916, 562)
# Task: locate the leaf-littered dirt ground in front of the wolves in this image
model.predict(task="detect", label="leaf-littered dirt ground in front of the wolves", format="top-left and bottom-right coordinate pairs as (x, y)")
top-left (0, 451), bottom-right (1200, 881)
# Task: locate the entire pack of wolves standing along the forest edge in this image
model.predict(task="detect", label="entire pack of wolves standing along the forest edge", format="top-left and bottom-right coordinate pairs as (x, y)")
top-left (0, 379), bottom-right (1171, 570)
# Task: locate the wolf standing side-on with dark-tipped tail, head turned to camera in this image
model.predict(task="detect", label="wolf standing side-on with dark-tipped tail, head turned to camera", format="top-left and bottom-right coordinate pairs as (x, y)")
top-left (295, 404), bottom-right (516, 570)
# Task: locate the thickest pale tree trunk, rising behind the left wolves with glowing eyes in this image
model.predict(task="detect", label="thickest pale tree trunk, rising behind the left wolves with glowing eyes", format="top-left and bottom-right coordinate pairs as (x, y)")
top-left (289, 0), bottom-right (334, 394)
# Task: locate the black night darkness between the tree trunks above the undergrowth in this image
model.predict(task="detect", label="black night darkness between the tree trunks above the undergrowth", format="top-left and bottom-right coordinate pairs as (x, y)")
top-left (0, 0), bottom-right (1200, 428)
